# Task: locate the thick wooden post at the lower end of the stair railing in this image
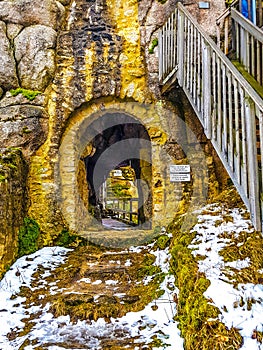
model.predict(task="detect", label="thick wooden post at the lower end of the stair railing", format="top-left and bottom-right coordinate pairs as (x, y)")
top-left (245, 98), bottom-right (261, 230)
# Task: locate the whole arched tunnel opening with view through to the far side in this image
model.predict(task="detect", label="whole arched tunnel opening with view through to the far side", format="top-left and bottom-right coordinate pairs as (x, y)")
top-left (81, 113), bottom-right (152, 229)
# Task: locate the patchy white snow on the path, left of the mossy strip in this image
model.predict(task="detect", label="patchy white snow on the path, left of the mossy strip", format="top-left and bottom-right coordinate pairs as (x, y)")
top-left (0, 245), bottom-right (183, 350)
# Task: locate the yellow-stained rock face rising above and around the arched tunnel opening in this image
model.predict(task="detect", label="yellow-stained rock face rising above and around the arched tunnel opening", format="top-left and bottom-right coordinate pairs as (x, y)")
top-left (28, 0), bottom-right (221, 244)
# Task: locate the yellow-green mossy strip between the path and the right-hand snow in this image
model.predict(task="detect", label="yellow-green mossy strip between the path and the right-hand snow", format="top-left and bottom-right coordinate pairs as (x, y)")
top-left (170, 217), bottom-right (242, 350)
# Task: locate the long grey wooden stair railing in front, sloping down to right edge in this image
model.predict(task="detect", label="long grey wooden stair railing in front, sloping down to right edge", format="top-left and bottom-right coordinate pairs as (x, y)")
top-left (159, 3), bottom-right (263, 230)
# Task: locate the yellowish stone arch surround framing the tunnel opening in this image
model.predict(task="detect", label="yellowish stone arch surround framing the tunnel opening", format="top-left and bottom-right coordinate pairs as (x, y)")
top-left (27, 99), bottom-right (207, 244)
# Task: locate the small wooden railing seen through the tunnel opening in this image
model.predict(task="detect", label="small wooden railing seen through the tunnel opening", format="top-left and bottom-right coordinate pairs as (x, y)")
top-left (105, 197), bottom-right (139, 225)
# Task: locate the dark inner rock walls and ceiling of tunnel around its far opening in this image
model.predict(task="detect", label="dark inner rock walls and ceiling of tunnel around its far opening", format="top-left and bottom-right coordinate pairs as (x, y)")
top-left (77, 112), bottom-right (152, 228)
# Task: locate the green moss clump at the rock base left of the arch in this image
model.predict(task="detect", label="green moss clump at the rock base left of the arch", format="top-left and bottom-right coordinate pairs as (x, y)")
top-left (18, 218), bottom-right (40, 257)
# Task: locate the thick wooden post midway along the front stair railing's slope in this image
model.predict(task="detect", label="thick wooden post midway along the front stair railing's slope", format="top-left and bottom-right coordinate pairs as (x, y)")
top-left (202, 41), bottom-right (212, 139)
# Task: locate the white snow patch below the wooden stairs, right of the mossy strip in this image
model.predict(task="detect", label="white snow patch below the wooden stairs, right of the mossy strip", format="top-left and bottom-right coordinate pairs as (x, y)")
top-left (189, 205), bottom-right (263, 350)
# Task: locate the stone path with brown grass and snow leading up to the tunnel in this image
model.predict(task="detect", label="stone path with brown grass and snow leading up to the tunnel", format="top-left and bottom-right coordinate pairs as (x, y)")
top-left (0, 241), bottom-right (181, 350)
